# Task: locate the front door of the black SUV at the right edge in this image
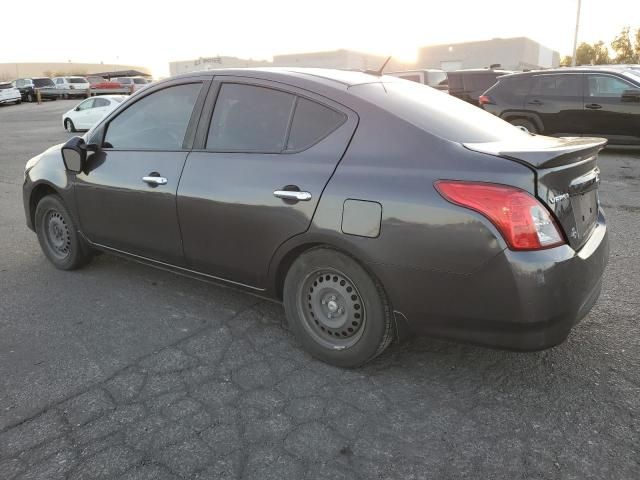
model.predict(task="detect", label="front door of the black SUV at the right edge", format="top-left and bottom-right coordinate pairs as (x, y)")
top-left (584, 73), bottom-right (640, 144)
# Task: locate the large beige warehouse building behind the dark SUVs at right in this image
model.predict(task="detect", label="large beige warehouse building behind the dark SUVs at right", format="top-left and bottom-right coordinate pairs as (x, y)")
top-left (417, 37), bottom-right (560, 71)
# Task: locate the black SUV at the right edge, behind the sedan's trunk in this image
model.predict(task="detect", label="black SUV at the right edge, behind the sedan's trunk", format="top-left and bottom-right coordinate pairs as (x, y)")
top-left (480, 67), bottom-right (640, 145)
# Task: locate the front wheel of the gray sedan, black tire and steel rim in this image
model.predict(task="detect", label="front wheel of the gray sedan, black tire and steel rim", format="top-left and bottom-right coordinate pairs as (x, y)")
top-left (35, 195), bottom-right (92, 270)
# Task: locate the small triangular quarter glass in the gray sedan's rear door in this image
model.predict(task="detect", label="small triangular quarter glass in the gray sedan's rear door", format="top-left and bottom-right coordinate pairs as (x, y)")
top-left (287, 98), bottom-right (346, 150)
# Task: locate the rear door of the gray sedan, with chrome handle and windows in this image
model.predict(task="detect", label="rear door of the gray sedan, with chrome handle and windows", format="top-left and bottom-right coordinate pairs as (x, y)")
top-left (178, 77), bottom-right (357, 288)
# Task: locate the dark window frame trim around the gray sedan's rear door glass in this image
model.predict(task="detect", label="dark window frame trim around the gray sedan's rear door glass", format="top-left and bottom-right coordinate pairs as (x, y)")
top-left (192, 75), bottom-right (352, 155)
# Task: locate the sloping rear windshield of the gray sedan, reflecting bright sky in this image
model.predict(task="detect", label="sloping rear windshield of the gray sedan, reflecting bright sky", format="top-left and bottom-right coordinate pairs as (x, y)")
top-left (349, 82), bottom-right (528, 143)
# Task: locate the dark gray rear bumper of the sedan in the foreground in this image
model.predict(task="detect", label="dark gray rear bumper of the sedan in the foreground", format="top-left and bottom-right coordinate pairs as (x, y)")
top-left (372, 212), bottom-right (609, 350)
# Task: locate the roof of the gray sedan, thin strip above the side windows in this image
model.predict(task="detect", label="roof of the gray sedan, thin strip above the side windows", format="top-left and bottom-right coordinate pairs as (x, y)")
top-left (171, 67), bottom-right (390, 88)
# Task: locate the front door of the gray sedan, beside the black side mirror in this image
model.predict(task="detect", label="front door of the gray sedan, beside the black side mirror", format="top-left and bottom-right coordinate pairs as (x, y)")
top-left (75, 76), bottom-right (210, 266)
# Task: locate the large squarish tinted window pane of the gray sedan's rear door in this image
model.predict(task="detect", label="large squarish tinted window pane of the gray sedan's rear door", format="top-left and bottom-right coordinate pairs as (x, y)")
top-left (207, 83), bottom-right (295, 153)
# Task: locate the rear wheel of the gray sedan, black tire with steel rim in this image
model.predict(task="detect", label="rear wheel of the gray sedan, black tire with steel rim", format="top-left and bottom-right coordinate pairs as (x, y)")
top-left (284, 248), bottom-right (393, 368)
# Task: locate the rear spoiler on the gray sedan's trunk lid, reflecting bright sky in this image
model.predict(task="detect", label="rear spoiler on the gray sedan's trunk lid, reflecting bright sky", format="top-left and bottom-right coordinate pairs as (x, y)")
top-left (463, 135), bottom-right (607, 168)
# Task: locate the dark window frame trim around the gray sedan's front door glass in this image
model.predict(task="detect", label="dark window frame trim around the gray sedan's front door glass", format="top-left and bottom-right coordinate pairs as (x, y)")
top-left (99, 76), bottom-right (211, 152)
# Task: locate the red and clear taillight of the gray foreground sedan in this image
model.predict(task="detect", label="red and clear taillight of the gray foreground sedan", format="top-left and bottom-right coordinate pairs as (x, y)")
top-left (435, 180), bottom-right (565, 250)
